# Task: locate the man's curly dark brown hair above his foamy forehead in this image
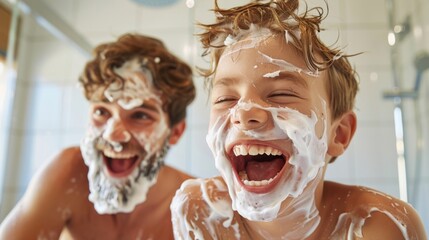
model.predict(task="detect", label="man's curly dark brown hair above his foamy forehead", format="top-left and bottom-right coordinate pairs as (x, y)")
top-left (79, 34), bottom-right (195, 126)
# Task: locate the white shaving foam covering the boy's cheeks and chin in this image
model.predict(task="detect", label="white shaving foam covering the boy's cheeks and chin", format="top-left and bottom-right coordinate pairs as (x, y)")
top-left (207, 101), bottom-right (327, 227)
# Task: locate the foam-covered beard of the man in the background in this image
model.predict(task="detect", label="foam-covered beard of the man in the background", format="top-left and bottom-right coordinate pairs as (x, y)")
top-left (81, 129), bottom-right (169, 214)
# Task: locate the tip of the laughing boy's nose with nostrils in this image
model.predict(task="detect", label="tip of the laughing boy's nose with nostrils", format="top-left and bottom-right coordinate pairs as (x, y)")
top-left (231, 107), bottom-right (268, 130)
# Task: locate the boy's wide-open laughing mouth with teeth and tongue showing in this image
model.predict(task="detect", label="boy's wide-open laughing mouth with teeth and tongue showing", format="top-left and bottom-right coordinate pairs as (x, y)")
top-left (230, 144), bottom-right (288, 193)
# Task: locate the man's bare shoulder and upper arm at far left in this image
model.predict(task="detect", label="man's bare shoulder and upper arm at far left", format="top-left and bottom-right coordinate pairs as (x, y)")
top-left (0, 148), bottom-right (88, 239)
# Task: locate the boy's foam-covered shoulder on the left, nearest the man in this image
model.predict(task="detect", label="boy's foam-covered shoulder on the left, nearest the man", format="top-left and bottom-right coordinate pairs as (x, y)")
top-left (170, 177), bottom-right (247, 239)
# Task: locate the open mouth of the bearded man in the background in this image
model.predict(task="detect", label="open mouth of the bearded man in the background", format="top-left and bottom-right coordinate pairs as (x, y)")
top-left (103, 151), bottom-right (139, 178)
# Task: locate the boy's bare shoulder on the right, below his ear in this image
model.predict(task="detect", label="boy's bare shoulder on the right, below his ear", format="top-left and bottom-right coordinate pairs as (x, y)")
top-left (324, 182), bottom-right (426, 239)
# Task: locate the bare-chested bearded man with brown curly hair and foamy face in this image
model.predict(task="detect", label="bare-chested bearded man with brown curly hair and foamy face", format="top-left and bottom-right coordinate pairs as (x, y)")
top-left (0, 34), bottom-right (195, 240)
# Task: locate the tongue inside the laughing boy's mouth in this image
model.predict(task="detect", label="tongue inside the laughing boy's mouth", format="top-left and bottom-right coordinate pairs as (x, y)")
top-left (246, 158), bottom-right (284, 181)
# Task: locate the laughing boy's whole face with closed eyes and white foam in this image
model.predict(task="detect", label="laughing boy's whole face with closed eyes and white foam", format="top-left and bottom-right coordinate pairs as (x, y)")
top-left (207, 36), bottom-right (328, 225)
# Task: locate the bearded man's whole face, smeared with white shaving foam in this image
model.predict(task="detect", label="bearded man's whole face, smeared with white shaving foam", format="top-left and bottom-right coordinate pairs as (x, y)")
top-left (81, 59), bottom-right (170, 214)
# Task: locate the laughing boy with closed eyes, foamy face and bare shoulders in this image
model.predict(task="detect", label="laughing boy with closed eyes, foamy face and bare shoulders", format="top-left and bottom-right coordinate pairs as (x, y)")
top-left (171, 0), bottom-right (426, 240)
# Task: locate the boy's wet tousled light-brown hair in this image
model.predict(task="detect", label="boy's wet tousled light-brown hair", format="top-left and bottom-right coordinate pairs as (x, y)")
top-left (199, 0), bottom-right (358, 119)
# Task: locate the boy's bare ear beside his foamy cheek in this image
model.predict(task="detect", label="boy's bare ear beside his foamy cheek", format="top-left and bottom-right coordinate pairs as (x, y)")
top-left (328, 111), bottom-right (356, 157)
